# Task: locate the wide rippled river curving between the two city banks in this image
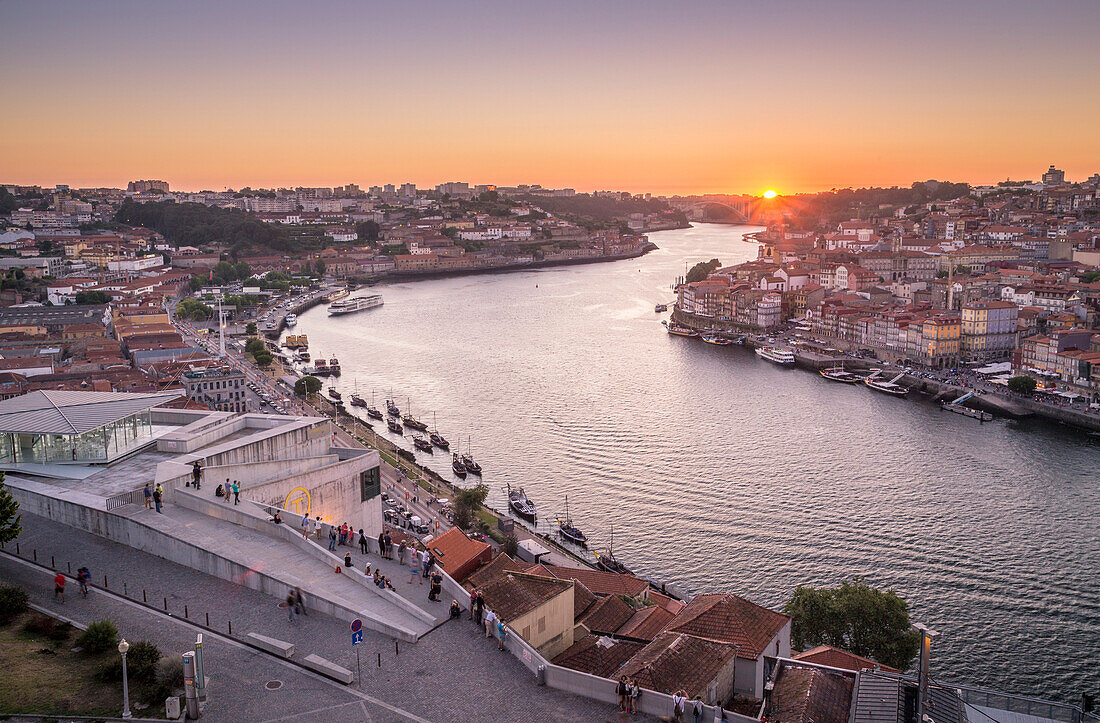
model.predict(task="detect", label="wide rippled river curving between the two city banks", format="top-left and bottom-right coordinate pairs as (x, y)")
top-left (296, 224), bottom-right (1100, 702)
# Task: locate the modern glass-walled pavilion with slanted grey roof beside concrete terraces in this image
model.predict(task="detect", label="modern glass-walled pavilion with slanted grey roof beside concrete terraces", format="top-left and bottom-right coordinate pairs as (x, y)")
top-left (0, 391), bottom-right (180, 464)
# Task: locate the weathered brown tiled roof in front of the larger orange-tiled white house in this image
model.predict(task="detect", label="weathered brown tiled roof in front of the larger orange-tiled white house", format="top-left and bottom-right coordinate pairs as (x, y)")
top-left (612, 633), bottom-right (737, 698)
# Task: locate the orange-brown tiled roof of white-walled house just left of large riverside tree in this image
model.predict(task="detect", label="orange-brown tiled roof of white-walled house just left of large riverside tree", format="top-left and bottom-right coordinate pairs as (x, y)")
top-left (668, 592), bottom-right (791, 660)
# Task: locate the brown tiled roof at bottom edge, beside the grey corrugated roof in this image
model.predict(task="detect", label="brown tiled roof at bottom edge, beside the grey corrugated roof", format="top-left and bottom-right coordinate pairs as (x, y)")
top-left (767, 664), bottom-right (855, 723)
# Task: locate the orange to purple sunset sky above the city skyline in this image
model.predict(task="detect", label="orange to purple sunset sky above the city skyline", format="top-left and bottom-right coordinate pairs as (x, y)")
top-left (0, 0), bottom-right (1100, 194)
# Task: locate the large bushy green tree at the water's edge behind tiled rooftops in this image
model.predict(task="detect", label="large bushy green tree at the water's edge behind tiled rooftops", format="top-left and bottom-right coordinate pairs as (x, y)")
top-left (783, 580), bottom-right (921, 670)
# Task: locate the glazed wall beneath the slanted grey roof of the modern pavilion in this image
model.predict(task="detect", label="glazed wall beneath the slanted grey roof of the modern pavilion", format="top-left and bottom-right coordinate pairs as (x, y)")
top-left (0, 409), bottom-right (176, 464)
